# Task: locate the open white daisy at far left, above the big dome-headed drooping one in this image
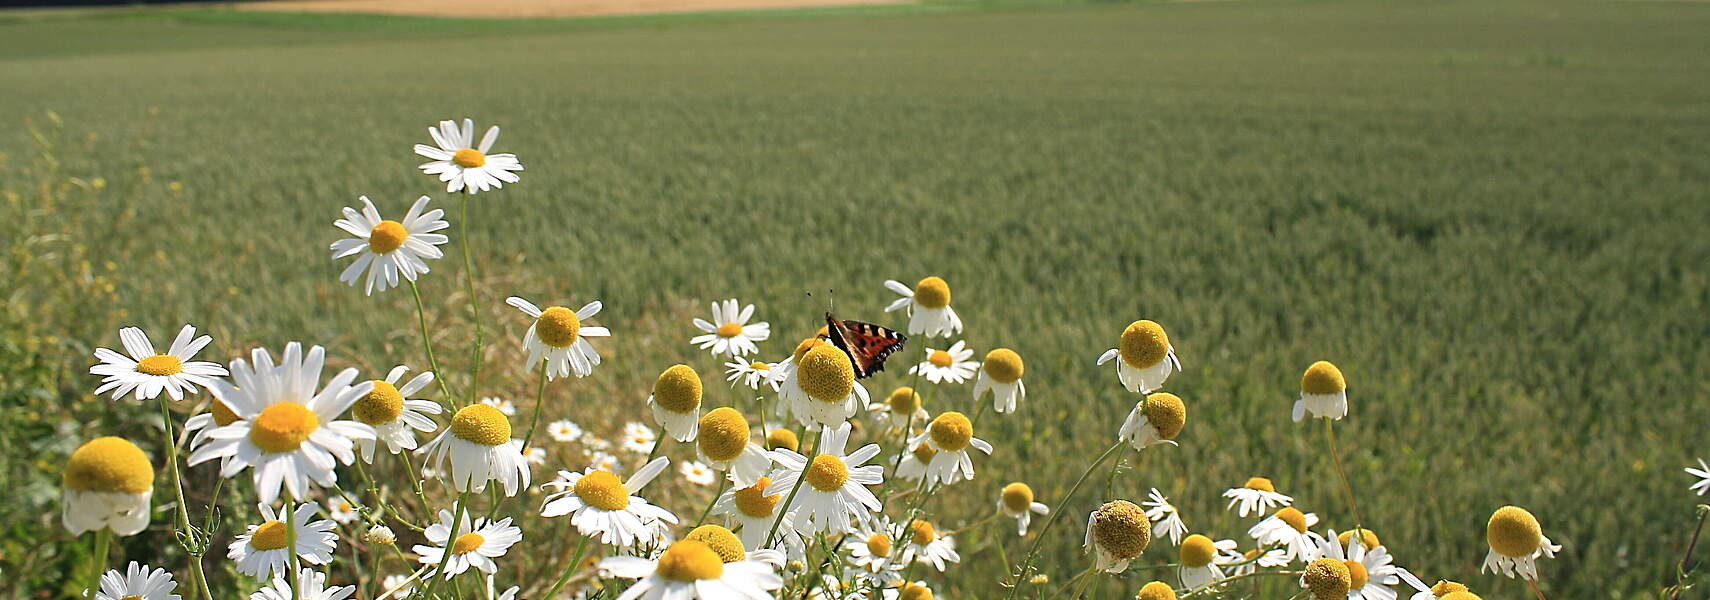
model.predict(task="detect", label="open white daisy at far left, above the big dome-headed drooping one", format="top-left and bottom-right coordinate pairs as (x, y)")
top-left (89, 325), bottom-right (227, 400)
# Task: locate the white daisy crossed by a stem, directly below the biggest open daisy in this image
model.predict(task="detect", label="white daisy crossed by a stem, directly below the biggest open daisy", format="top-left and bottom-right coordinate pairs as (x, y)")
top-left (226, 503), bottom-right (339, 579)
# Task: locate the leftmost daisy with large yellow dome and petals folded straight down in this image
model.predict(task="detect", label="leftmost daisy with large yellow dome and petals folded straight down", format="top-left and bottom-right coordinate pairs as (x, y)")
top-left (60, 436), bottom-right (154, 535)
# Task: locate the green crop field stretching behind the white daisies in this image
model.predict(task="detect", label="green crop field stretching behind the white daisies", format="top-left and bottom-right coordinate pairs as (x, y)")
top-left (0, 2), bottom-right (1710, 600)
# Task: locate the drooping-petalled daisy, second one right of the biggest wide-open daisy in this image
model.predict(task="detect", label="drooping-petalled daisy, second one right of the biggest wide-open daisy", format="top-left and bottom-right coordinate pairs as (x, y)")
top-left (417, 403), bottom-right (530, 496)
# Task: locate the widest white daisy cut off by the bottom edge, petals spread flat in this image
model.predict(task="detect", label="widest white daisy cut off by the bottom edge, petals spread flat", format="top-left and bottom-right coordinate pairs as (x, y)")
top-left (600, 540), bottom-right (783, 600)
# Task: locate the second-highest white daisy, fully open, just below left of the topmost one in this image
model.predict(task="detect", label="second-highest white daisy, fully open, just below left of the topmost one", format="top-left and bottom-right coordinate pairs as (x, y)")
top-left (332, 197), bottom-right (451, 296)
